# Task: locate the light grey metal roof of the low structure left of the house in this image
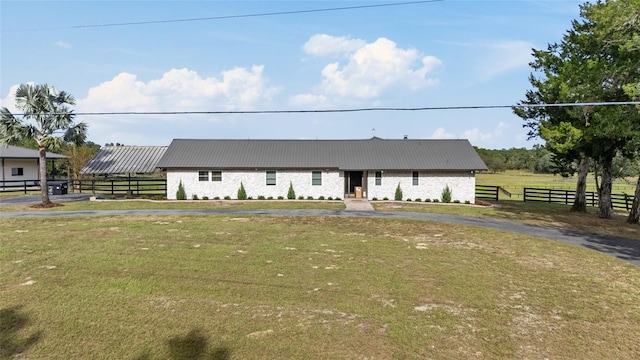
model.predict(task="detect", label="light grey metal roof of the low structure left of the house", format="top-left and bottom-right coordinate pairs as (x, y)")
top-left (80, 146), bottom-right (167, 174)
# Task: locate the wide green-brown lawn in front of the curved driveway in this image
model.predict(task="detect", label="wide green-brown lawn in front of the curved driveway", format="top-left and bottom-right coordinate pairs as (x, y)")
top-left (0, 215), bottom-right (640, 359)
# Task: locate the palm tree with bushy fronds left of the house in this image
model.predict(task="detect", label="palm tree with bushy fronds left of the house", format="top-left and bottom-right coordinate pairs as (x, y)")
top-left (0, 84), bottom-right (87, 205)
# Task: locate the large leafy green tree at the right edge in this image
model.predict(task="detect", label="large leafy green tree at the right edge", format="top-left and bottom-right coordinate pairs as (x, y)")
top-left (514, 0), bottom-right (640, 218)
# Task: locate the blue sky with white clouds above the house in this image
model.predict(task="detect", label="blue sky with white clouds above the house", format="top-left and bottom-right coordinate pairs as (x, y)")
top-left (0, 0), bottom-right (582, 149)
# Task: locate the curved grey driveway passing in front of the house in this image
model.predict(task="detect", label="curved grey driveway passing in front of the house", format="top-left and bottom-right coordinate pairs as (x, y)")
top-left (0, 205), bottom-right (640, 267)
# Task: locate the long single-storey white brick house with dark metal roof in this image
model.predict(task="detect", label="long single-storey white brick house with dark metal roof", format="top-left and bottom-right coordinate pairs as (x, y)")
top-left (157, 137), bottom-right (487, 203)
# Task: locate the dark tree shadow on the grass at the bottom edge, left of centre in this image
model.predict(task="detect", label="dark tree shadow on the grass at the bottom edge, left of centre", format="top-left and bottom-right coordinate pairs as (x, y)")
top-left (136, 329), bottom-right (231, 360)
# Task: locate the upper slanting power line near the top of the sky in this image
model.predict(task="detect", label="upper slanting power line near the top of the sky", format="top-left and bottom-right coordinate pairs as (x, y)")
top-left (18, 0), bottom-right (445, 31)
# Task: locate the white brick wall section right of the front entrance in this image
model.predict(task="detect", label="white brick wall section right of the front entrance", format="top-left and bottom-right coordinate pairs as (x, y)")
top-left (367, 171), bottom-right (476, 204)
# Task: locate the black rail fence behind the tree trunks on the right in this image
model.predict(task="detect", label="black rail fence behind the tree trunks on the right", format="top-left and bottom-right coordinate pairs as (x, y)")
top-left (523, 188), bottom-right (633, 211)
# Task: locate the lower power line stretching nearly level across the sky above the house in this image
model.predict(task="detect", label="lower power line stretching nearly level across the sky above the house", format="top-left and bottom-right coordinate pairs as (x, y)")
top-left (13, 101), bottom-right (640, 116)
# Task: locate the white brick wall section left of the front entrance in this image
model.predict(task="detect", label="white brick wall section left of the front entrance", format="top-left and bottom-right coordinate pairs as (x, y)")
top-left (167, 170), bottom-right (344, 199)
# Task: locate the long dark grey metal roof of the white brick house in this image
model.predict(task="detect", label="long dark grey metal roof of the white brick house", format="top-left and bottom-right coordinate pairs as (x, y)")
top-left (157, 137), bottom-right (487, 170)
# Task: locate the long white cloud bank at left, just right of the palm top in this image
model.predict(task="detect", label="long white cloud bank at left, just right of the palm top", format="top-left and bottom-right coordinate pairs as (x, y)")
top-left (78, 66), bottom-right (279, 112)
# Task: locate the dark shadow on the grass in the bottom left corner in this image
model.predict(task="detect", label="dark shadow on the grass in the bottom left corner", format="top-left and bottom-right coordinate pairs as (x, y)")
top-left (0, 306), bottom-right (42, 359)
